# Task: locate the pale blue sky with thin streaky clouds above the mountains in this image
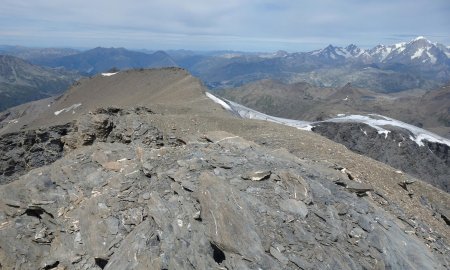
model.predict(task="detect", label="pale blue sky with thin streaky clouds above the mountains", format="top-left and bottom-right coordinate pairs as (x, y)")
top-left (0, 0), bottom-right (450, 51)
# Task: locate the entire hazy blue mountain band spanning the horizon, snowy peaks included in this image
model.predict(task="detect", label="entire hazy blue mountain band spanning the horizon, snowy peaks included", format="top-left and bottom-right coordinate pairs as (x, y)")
top-left (0, 37), bottom-right (450, 109)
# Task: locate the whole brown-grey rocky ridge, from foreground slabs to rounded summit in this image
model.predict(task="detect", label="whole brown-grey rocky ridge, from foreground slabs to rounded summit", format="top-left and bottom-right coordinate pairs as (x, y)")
top-left (0, 68), bottom-right (450, 270)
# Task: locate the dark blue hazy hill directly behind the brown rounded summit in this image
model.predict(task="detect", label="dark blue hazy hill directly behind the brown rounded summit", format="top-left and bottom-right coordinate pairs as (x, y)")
top-left (38, 47), bottom-right (178, 75)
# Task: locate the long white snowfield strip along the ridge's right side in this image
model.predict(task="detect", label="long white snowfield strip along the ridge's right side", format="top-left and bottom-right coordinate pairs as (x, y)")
top-left (206, 92), bottom-right (450, 146)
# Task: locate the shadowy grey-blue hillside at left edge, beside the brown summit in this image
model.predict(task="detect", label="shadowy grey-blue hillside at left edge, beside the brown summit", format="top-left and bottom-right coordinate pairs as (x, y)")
top-left (0, 55), bottom-right (79, 111)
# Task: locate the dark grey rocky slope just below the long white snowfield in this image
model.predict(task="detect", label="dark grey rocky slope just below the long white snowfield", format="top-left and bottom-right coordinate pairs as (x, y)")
top-left (312, 121), bottom-right (450, 192)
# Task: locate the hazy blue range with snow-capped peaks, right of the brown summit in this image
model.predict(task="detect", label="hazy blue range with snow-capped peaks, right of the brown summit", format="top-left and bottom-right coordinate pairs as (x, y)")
top-left (181, 37), bottom-right (450, 92)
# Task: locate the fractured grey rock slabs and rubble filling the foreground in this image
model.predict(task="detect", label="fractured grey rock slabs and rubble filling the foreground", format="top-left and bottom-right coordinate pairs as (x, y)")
top-left (0, 121), bottom-right (448, 269)
